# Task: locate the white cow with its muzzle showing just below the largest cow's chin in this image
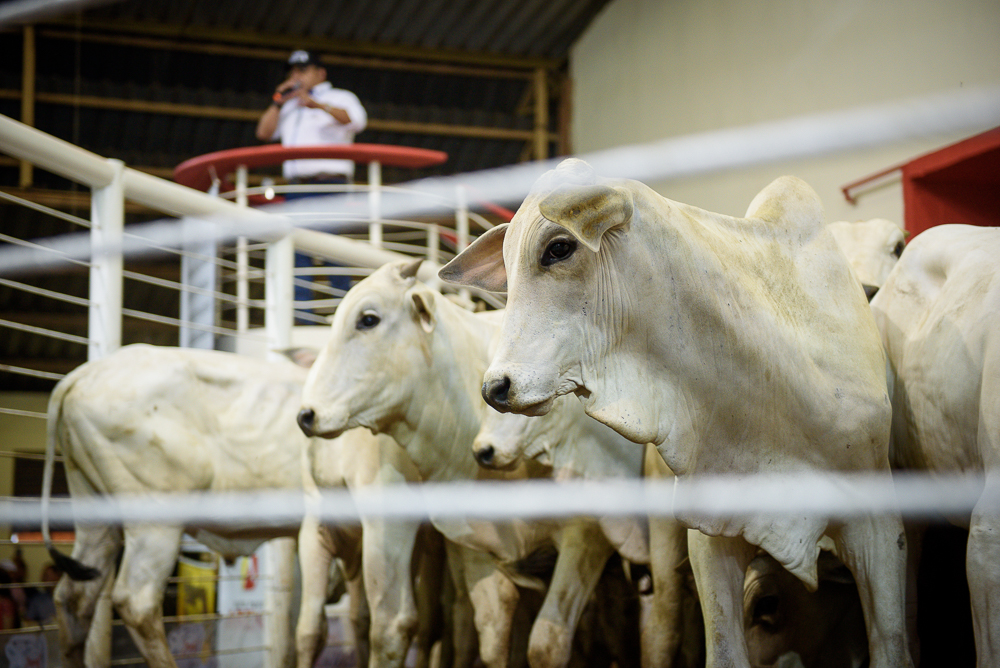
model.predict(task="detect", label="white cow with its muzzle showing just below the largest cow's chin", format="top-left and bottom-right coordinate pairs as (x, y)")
top-left (472, 397), bottom-right (687, 666)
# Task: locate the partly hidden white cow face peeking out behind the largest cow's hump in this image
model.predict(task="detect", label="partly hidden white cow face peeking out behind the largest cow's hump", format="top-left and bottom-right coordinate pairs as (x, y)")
top-left (827, 218), bottom-right (907, 300)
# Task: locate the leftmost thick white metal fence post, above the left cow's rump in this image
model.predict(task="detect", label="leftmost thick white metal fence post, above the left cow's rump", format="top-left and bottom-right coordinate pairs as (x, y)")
top-left (87, 159), bottom-right (125, 360)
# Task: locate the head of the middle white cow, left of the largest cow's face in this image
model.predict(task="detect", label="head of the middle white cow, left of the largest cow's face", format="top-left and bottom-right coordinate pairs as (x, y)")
top-left (298, 260), bottom-right (440, 438)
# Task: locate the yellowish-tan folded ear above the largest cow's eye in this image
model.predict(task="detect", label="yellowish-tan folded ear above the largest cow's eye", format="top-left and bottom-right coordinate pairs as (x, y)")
top-left (538, 186), bottom-right (632, 253)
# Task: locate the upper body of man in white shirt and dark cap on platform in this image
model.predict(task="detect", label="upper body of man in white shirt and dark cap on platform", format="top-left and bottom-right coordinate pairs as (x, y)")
top-left (257, 51), bottom-right (368, 183)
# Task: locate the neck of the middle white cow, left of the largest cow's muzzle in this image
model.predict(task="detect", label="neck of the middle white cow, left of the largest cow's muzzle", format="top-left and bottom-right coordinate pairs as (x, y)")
top-left (393, 298), bottom-right (496, 481)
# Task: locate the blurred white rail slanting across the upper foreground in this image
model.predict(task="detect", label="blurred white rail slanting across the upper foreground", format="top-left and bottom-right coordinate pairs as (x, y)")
top-left (0, 85), bottom-right (1000, 271)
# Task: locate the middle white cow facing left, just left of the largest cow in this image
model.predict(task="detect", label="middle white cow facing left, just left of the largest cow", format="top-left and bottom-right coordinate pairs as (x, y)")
top-left (299, 260), bottom-right (632, 668)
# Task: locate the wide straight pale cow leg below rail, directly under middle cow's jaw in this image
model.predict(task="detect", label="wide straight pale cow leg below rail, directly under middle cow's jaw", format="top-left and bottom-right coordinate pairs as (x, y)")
top-left (362, 518), bottom-right (420, 668)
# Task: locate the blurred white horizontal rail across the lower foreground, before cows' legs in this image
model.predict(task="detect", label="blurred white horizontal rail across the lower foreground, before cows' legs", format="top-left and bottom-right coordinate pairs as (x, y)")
top-left (0, 471), bottom-right (984, 529)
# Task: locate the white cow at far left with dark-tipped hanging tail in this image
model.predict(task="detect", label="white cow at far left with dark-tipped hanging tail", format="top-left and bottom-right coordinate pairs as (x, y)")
top-left (39, 345), bottom-right (438, 667)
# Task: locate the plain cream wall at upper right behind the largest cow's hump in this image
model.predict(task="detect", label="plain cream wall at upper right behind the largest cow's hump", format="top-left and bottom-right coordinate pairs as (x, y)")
top-left (570, 0), bottom-right (1000, 223)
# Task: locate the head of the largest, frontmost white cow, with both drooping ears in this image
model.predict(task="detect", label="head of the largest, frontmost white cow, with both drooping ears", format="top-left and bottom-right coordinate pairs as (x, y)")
top-left (440, 160), bottom-right (641, 422)
